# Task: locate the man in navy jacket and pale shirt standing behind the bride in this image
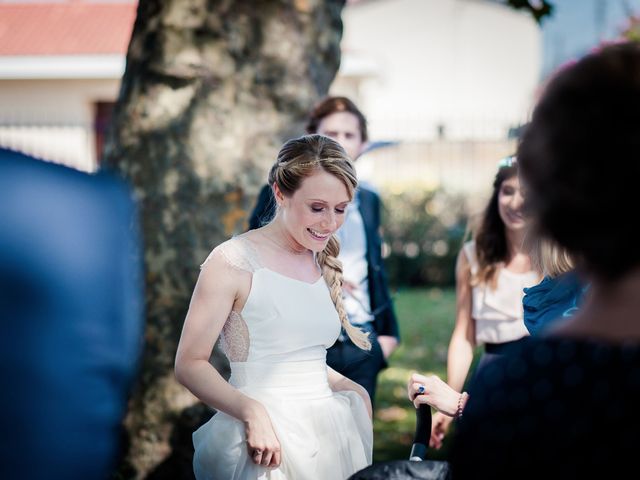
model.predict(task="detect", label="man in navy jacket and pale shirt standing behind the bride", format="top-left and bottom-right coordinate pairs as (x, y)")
top-left (249, 97), bottom-right (399, 401)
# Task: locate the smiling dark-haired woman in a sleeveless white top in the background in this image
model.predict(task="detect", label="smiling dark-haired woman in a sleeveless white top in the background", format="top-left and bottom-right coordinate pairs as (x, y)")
top-left (430, 157), bottom-right (541, 448)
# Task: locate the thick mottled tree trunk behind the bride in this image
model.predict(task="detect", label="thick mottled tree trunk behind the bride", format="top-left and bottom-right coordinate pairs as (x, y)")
top-left (105, 0), bottom-right (344, 479)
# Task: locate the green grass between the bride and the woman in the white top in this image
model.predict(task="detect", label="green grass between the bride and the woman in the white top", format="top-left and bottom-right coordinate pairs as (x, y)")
top-left (373, 288), bottom-right (455, 462)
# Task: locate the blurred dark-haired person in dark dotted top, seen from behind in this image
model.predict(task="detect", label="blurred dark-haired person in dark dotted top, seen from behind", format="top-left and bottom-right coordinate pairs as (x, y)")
top-left (452, 43), bottom-right (640, 480)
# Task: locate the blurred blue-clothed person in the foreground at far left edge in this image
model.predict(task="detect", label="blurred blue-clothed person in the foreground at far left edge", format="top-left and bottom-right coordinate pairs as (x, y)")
top-left (0, 148), bottom-right (143, 480)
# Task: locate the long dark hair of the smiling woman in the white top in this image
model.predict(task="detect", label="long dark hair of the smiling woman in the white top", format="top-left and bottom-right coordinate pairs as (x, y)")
top-left (472, 163), bottom-right (518, 285)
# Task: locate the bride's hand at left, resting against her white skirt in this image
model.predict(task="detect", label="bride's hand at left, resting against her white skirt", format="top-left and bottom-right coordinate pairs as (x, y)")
top-left (244, 400), bottom-right (281, 468)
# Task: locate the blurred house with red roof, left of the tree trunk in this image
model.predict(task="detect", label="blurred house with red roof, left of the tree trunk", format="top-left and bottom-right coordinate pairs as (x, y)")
top-left (0, 1), bottom-right (137, 171)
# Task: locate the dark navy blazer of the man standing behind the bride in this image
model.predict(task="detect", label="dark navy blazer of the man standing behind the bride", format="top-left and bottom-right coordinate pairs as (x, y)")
top-left (249, 185), bottom-right (400, 339)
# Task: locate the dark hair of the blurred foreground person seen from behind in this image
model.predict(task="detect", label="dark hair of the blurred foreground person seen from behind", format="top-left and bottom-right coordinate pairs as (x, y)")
top-left (517, 43), bottom-right (640, 280)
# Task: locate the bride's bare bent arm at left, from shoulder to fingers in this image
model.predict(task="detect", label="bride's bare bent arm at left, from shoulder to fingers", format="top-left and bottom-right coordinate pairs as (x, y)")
top-left (175, 254), bottom-right (280, 466)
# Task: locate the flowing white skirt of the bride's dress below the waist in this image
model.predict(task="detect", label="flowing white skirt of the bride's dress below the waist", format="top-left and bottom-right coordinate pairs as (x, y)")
top-left (193, 360), bottom-right (373, 480)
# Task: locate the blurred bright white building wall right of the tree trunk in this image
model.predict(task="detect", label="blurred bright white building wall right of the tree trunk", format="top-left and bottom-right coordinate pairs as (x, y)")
top-left (332, 0), bottom-right (541, 141)
